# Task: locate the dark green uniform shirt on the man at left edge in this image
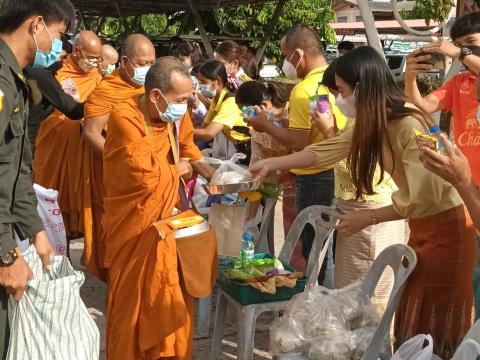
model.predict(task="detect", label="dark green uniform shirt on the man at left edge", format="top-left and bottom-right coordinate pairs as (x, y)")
top-left (0, 38), bottom-right (43, 255)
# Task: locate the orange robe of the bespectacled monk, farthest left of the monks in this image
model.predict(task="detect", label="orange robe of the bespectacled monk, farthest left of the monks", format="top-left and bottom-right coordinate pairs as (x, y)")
top-left (34, 56), bottom-right (102, 238)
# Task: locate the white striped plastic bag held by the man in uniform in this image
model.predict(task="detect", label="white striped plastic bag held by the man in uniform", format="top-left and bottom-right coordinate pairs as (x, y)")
top-left (7, 246), bottom-right (100, 360)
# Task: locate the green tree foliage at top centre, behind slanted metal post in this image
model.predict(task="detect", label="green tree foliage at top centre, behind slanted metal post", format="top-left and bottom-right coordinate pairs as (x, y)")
top-left (218, 0), bottom-right (336, 61)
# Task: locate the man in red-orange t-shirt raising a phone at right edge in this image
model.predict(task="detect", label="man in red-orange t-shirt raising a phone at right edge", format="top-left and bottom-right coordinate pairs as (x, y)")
top-left (405, 12), bottom-right (480, 187)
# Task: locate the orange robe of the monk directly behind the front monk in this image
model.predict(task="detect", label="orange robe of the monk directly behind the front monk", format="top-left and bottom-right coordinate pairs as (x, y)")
top-left (82, 70), bottom-right (145, 280)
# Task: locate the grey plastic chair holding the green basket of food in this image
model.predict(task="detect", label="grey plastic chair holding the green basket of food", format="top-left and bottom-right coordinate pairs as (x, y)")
top-left (210, 205), bottom-right (338, 360)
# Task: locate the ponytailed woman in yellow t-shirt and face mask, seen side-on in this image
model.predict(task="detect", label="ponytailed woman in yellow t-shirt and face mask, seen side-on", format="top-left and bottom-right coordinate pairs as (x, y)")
top-left (193, 60), bottom-right (250, 159)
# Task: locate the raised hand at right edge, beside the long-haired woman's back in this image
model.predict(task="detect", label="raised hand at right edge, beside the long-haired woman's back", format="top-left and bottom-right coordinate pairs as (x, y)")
top-left (420, 134), bottom-right (472, 188)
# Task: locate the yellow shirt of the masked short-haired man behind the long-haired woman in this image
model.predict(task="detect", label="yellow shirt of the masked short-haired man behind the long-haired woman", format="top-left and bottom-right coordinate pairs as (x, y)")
top-left (288, 65), bottom-right (346, 175)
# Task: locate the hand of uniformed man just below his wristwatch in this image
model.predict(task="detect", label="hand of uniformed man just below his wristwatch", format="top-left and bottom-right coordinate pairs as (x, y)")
top-left (0, 249), bottom-right (33, 301)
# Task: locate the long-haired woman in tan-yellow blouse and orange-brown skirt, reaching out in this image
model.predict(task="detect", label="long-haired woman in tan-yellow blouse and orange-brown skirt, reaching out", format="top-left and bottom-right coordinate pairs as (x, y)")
top-left (251, 46), bottom-right (477, 359)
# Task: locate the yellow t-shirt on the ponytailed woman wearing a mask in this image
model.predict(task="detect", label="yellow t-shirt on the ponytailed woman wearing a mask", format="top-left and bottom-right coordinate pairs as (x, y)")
top-left (204, 89), bottom-right (250, 142)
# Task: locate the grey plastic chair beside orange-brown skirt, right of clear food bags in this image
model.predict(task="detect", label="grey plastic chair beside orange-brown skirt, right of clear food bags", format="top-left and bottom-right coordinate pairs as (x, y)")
top-left (274, 244), bottom-right (417, 360)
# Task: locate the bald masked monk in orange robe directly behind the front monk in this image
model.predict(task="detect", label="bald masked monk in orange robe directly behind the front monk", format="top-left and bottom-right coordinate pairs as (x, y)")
top-left (83, 34), bottom-right (155, 280)
